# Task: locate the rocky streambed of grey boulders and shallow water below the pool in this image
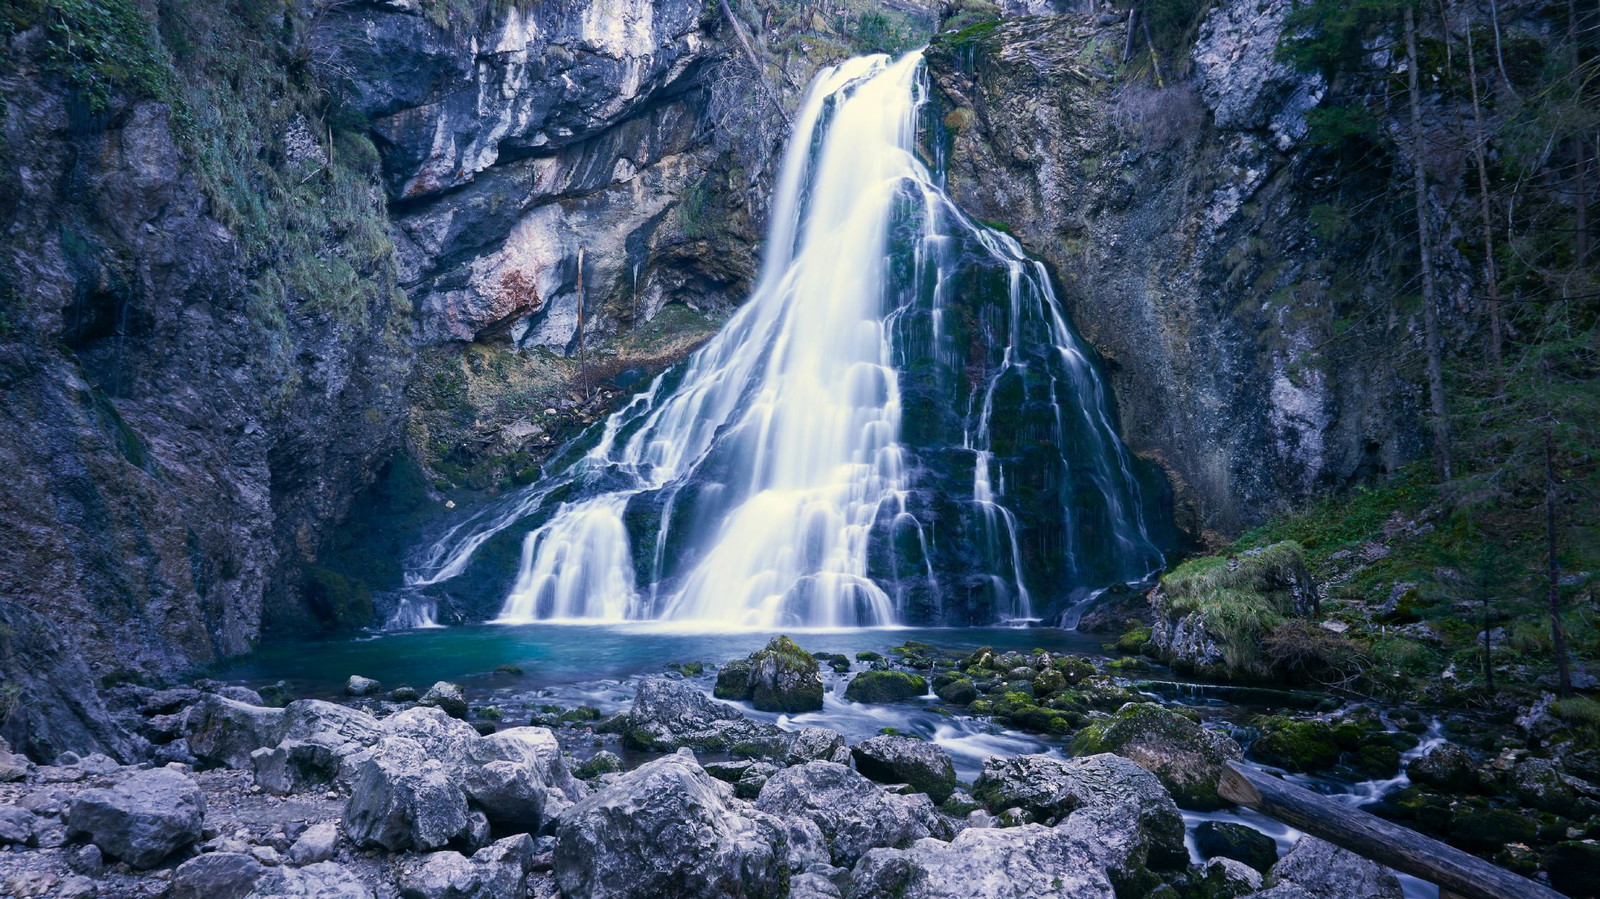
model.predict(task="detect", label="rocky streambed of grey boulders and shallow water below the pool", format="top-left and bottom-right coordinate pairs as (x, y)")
top-left (0, 638), bottom-right (1587, 899)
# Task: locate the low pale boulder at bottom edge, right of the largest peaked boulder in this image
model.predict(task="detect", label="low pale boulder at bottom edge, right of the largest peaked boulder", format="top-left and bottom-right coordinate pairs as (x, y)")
top-left (851, 824), bottom-right (1117, 899)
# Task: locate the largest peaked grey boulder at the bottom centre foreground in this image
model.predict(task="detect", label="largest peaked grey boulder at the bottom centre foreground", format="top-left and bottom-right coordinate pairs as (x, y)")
top-left (555, 752), bottom-right (821, 899)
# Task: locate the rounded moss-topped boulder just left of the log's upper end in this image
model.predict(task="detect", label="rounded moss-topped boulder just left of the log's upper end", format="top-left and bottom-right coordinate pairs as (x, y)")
top-left (1072, 702), bottom-right (1245, 811)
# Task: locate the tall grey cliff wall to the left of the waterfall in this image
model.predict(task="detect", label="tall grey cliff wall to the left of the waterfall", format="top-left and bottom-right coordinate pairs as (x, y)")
top-left (0, 0), bottom-right (754, 758)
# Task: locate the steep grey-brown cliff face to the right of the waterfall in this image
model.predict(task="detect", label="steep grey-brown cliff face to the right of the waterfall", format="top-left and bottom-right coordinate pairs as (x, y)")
top-left (928, 8), bottom-right (1440, 539)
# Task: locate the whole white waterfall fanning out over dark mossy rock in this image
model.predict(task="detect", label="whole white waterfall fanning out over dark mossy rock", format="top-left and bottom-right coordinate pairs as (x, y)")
top-left (408, 53), bottom-right (1162, 629)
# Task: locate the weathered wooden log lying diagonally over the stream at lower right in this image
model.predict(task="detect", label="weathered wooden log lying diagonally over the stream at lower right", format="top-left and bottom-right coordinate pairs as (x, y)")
top-left (1216, 761), bottom-right (1562, 899)
